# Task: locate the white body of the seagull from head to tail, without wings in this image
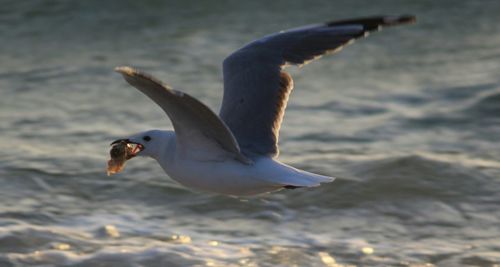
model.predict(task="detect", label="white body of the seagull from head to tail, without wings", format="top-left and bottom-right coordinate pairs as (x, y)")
top-left (135, 130), bottom-right (333, 196)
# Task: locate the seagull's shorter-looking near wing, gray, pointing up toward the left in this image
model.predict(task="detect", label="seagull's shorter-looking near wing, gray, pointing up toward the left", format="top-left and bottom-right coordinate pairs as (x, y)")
top-left (115, 67), bottom-right (249, 163)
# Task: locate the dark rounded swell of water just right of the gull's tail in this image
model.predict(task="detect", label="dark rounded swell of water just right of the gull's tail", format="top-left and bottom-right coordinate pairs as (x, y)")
top-left (284, 155), bottom-right (494, 208)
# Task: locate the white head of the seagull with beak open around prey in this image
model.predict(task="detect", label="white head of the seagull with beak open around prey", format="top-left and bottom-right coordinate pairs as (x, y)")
top-left (111, 130), bottom-right (166, 159)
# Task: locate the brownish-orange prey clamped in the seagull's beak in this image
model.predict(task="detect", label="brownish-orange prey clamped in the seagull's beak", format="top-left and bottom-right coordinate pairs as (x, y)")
top-left (107, 139), bottom-right (144, 176)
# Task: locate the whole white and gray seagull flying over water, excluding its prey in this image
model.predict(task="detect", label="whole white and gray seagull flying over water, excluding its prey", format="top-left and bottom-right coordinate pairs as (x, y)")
top-left (112, 15), bottom-right (415, 196)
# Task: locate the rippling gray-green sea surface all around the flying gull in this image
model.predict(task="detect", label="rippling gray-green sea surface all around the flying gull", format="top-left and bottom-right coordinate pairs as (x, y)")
top-left (0, 0), bottom-right (500, 267)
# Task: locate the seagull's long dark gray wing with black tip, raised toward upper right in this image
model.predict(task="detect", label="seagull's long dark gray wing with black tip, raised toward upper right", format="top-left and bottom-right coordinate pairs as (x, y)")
top-left (220, 16), bottom-right (415, 156)
